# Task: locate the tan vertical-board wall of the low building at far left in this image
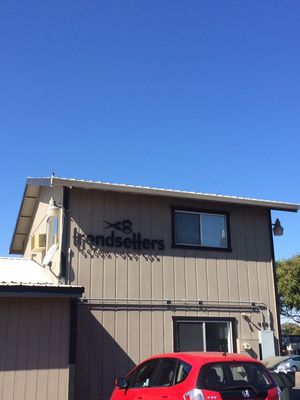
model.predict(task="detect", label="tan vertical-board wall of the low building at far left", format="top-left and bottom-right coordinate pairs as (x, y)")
top-left (0, 298), bottom-right (69, 400)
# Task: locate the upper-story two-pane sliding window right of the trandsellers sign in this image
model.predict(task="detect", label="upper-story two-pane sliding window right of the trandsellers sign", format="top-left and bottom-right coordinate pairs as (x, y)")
top-left (173, 210), bottom-right (229, 249)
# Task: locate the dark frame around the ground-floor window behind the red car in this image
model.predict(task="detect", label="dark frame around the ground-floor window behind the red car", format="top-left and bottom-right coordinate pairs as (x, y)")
top-left (172, 317), bottom-right (237, 353)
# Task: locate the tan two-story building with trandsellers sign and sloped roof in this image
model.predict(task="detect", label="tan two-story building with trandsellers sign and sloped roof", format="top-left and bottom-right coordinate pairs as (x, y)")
top-left (6, 177), bottom-right (299, 400)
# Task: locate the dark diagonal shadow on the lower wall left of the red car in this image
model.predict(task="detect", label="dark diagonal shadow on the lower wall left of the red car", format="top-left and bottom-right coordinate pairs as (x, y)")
top-left (75, 305), bottom-right (135, 400)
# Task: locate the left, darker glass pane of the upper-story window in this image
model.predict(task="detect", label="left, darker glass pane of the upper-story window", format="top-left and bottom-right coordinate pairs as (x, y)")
top-left (175, 211), bottom-right (200, 245)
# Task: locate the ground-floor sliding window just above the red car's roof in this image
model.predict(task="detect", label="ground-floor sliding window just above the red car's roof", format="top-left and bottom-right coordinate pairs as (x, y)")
top-left (173, 317), bottom-right (234, 352)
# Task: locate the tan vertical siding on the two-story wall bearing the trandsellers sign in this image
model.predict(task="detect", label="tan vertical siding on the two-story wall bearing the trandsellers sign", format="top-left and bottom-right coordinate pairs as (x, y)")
top-left (69, 188), bottom-right (278, 400)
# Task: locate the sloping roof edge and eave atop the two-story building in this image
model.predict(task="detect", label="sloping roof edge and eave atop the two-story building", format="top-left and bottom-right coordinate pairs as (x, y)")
top-left (10, 177), bottom-right (300, 254)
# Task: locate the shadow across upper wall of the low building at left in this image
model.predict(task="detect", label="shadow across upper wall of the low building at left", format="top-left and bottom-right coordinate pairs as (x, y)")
top-left (0, 298), bottom-right (70, 372)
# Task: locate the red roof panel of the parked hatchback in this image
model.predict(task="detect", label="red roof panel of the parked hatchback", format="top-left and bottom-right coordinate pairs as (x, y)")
top-left (145, 352), bottom-right (259, 364)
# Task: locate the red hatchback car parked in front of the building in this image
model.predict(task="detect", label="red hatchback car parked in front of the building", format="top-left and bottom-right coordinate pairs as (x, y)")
top-left (110, 352), bottom-right (281, 400)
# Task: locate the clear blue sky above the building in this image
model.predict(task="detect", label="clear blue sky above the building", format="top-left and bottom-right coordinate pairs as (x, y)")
top-left (0, 0), bottom-right (300, 258)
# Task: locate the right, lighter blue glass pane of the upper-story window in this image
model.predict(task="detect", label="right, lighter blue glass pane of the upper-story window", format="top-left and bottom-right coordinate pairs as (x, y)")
top-left (201, 214), bottom-right (227, 247)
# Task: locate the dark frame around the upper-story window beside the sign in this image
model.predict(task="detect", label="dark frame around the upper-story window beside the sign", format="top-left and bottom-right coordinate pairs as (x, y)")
top-left (171, 206), bottom-right (232, 252)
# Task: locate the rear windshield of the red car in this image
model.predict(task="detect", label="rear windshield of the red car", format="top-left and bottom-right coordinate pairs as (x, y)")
top-left (198, 362), bottom-right (274, 390)
